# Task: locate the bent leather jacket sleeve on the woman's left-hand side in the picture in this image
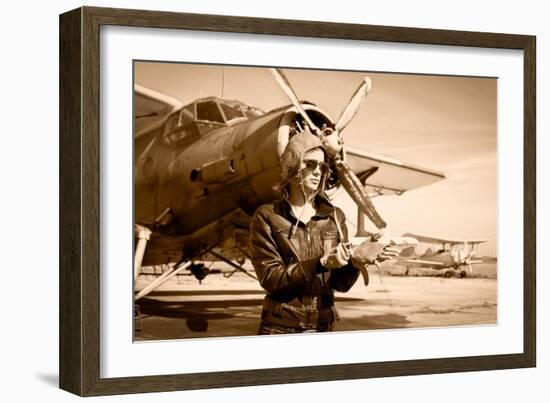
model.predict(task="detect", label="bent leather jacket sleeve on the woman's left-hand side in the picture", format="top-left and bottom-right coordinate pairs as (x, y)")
top-left (250, 207), bottom-right (319, 294)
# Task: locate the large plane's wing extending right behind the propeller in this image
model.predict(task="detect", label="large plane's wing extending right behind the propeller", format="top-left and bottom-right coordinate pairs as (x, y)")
top-left (346, 147), bottom-right (445, 195)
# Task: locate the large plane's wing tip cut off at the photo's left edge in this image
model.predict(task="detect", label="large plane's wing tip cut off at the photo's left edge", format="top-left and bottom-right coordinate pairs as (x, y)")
top-left (134, 84), bottom-right (183, 137)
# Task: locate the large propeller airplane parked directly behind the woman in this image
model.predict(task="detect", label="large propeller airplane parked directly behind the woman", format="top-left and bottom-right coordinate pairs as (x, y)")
top-left (134, 69), bottom-right (445, 301)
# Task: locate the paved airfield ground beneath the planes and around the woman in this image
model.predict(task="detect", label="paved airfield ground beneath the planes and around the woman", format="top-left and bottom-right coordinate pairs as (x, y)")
top-left (134, 263), bottom-right (497, 341)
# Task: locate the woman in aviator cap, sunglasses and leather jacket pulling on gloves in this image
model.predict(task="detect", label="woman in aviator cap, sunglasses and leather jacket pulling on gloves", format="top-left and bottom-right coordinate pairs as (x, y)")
top-left (250, 130), bottom-right (394, 334)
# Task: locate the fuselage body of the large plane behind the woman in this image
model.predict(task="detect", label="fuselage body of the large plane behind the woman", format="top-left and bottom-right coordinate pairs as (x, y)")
top-left (134, 101), bottom-right (329, 235)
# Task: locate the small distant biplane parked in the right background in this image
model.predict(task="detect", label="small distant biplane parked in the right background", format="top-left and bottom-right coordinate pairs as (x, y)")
top-left (397, 232), bottom-right (488, 278)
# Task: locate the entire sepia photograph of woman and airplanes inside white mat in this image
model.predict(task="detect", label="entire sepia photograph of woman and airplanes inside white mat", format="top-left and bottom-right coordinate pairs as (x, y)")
top-left (132, 60), bottom-right (498, 342)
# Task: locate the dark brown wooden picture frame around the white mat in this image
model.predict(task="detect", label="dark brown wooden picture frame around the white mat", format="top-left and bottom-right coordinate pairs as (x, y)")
top-left (59, 7), bottom-right (536, 396)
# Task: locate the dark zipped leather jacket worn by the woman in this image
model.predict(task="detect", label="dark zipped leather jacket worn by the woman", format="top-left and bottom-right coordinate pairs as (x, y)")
top-left (250, 194), bottom-right (359, 328)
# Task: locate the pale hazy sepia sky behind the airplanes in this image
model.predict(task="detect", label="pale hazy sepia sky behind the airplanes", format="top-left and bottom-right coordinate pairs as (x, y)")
top-left (134, 62), bottom-right (498, 256)
